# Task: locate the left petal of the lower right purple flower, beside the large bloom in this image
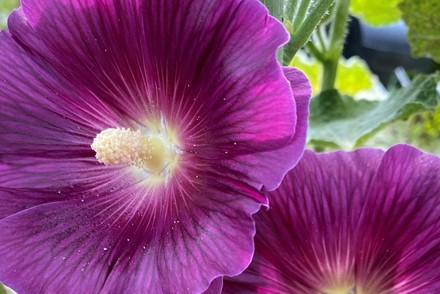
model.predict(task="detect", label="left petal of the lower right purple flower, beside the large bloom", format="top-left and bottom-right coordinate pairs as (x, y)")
top-left (234, 150), bottom-right (382, 293)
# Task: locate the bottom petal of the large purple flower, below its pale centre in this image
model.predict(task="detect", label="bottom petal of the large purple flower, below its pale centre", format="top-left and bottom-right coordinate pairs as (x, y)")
top-left (0, 169), bottom-right (259, 293)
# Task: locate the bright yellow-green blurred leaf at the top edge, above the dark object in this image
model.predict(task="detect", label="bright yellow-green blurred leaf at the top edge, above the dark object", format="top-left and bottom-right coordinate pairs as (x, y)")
top-left (350, 0), bottom-right (402, 26)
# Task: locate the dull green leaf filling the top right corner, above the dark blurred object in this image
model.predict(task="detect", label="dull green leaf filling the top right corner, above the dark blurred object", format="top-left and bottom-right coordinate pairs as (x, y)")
top-left (399, 0), bottom-right (440, 62)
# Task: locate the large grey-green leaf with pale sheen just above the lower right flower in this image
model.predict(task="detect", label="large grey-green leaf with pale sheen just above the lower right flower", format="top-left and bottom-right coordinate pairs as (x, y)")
top-left (308, 74), bottom-right (440, 149)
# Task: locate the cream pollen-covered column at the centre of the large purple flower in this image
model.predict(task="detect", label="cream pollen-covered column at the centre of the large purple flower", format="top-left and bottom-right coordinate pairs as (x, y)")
top-left (91, 128), bottom-right (177, 176)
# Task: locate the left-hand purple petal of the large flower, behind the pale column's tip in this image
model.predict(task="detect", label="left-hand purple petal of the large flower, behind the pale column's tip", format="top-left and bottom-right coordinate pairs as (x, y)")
top-left (0, 31), bottom-right (126, 193)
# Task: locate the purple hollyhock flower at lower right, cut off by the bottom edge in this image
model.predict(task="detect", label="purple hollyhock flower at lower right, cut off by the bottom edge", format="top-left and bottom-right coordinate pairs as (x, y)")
top-left (224, 145), bottom-right (440, 294)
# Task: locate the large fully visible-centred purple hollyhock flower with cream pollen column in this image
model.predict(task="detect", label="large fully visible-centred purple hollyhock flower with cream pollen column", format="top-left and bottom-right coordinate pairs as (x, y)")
top-left (0, 0), bottom-right (310, 293)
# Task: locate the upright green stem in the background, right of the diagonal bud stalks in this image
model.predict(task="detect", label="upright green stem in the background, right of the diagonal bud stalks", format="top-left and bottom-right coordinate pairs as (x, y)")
top-left (321, 0), bottom-right (350, 91)
